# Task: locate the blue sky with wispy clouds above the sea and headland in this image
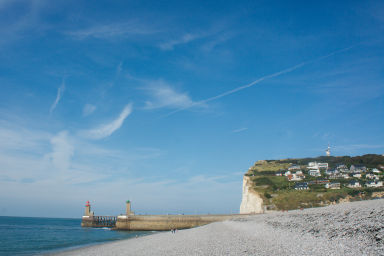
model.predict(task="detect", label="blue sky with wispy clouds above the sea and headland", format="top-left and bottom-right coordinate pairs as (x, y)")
top-left (0, 0), bottom-right (384, 217)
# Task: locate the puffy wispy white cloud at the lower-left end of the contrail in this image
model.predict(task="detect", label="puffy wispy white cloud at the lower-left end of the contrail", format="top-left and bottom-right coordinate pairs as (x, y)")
top-left (144, 80), bottom-right (200, 109)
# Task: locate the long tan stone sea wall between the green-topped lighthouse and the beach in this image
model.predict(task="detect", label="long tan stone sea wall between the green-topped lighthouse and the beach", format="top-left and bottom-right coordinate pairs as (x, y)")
top-left (116, 215), bottom-right (236, 231)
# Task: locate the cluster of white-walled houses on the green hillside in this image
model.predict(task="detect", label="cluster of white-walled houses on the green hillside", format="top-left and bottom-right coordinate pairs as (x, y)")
top-left (276, 162), bottom-right (383, 190)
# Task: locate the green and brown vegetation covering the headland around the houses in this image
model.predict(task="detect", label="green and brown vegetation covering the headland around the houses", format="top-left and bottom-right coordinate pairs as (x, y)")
top-left (245, 154), bottom-right (384, 210)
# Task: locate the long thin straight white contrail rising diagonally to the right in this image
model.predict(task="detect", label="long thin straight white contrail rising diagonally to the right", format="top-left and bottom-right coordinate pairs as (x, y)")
top-left (165, 44), bottom-right (358, 117)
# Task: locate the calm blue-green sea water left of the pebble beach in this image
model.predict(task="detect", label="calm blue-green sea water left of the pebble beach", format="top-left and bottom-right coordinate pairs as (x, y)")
top-left (0, 216), bottom-right (151, 255)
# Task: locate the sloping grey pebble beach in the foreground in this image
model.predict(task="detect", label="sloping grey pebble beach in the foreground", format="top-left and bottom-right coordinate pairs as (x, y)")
top-left (54, 199), bottom-right (384, 256)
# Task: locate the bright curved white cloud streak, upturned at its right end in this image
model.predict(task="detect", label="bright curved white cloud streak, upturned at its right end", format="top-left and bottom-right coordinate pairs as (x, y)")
top-left (81, 103), bottom-right (133, 139)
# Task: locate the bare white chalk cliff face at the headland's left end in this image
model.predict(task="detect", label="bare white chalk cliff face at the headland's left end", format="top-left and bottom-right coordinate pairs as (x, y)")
top-left (240, 176), bottom-right (264, 214)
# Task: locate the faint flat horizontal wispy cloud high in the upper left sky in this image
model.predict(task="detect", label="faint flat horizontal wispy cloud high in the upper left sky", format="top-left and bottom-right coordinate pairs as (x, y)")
top-left (66, 21), bottom-right (159, 40)
